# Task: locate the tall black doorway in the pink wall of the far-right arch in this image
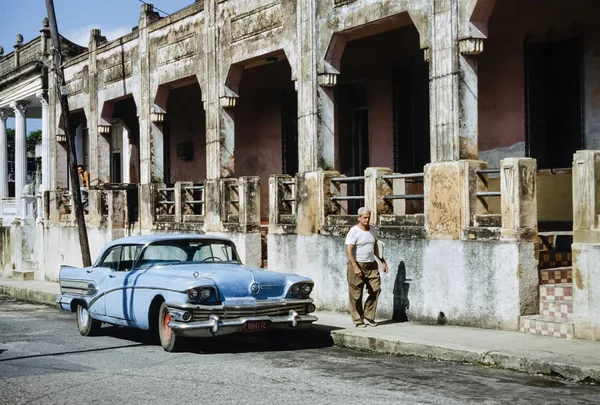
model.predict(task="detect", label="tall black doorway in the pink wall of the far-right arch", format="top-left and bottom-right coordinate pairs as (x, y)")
top-left (525, 37), bottom-right (584, 169)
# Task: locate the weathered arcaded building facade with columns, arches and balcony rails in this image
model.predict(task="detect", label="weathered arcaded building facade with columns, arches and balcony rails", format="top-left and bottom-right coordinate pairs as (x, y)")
top-left (0, 0), bottom-right (600, 339)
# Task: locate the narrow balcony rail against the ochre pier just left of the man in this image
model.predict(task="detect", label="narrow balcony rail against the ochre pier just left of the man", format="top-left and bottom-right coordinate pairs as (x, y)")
top-left (269, 174), bottom-right (297, 233)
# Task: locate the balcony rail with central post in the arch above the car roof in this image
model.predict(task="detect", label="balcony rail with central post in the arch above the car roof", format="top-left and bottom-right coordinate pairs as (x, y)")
top-left (154, 182), bottom-right (205, 223)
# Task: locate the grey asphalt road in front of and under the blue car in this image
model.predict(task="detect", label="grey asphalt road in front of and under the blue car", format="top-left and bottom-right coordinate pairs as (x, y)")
top-left (0, 298), bottom-right (600, 405)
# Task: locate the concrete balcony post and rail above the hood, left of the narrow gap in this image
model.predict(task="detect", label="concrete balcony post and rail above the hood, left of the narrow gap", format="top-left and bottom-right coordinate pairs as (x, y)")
top-left (220, 176), bottom-right (260, 232)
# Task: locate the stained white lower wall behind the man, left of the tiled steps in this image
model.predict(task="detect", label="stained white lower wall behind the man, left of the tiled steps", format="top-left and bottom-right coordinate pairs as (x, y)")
top-left (269, 234), bottom-right (538, 330)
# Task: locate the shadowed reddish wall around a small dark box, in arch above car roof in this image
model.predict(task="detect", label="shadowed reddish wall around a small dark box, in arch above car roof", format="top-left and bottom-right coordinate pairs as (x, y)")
top-left (167, 83), bottom-right (206, 183)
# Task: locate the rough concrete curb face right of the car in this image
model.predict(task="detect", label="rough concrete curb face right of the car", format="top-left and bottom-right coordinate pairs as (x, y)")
top-left (331, 331), bottom-right (600, 383)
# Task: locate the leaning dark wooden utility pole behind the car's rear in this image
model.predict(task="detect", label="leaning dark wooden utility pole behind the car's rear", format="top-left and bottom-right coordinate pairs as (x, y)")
top-left (46, 0), bottom-right (92, 267)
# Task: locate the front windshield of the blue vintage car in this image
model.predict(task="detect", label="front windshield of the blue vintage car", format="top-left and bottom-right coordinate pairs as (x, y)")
top-left (137, 239), bottom-right (241, 268)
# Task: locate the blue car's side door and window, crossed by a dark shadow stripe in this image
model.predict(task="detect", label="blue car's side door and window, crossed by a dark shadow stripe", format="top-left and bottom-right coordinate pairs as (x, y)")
top-left (105, 245), bottom-right (141, 326)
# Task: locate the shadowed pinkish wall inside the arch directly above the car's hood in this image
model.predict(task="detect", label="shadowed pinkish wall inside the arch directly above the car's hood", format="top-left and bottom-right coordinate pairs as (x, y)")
top-left (234, 61), bottom-right (295, 220)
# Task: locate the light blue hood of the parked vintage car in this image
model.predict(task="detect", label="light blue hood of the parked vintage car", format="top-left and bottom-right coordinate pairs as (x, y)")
top-left (163, 263), bottom-right (288, 300)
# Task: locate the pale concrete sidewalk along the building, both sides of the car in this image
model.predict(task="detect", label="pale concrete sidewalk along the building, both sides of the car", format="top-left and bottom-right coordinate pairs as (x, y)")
top-left (0, 278), bottom-right (600, 382)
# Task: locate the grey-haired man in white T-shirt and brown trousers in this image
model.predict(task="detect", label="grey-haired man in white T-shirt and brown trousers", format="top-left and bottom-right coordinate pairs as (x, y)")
top-left (346, 207), bottom-right (388, 328)
